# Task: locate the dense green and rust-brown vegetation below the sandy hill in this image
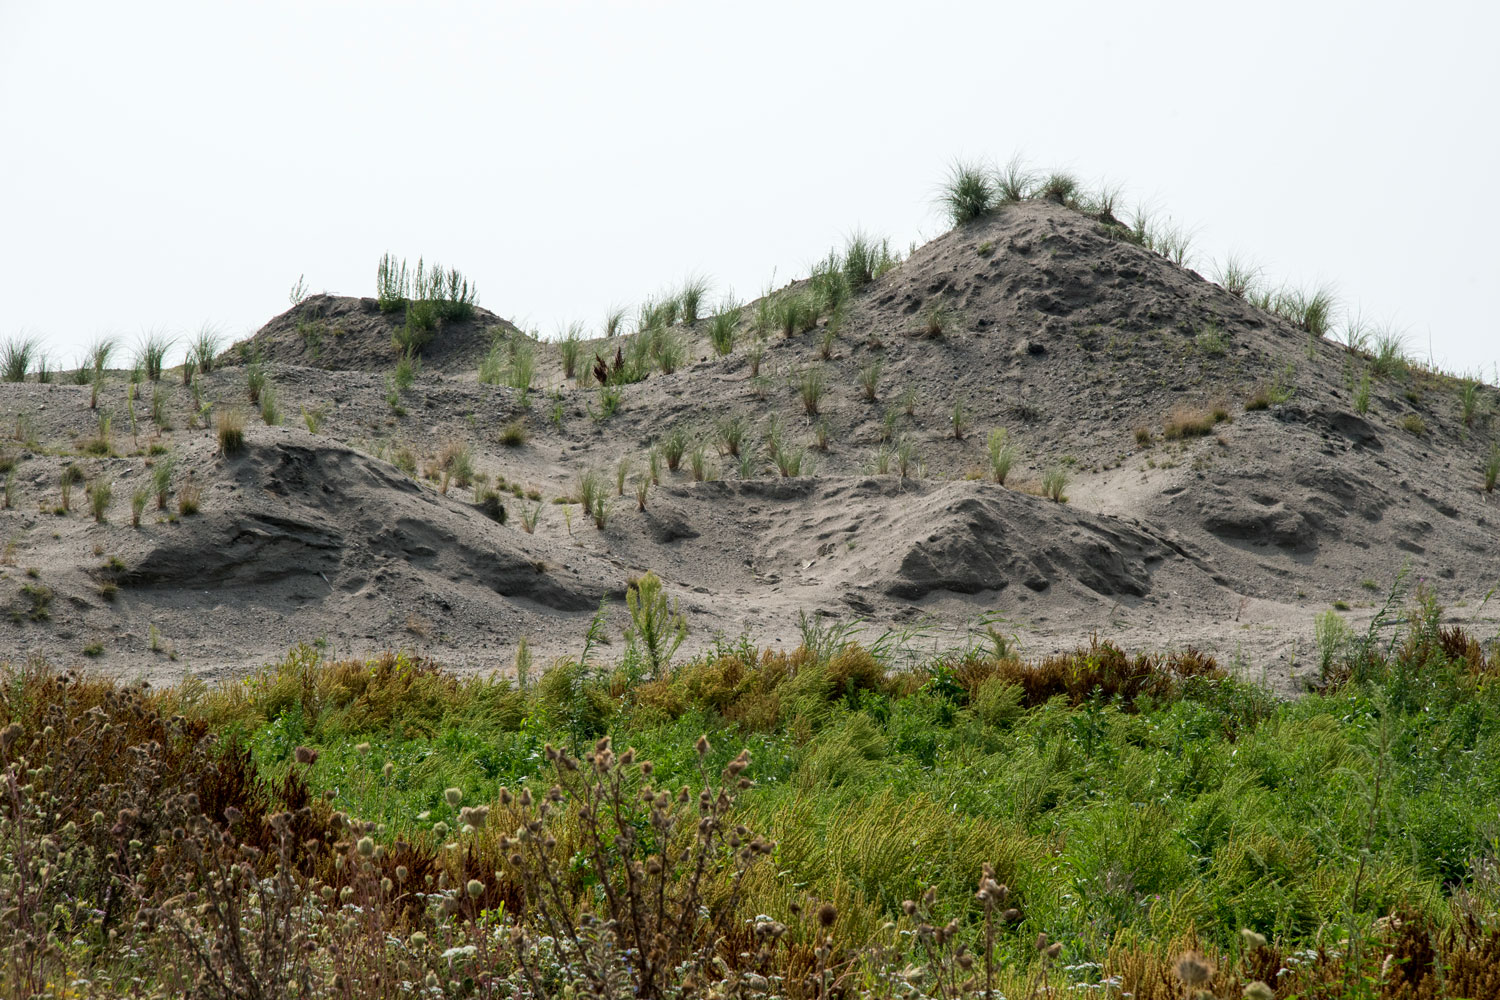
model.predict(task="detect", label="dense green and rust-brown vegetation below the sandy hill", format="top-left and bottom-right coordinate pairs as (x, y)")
top-left (0, 590), bottom-right (1500, 997)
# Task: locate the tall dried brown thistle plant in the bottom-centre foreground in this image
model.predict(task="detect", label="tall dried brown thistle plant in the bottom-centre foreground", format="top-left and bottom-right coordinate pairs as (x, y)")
top-left (501, 736), bottom-right (768, 999)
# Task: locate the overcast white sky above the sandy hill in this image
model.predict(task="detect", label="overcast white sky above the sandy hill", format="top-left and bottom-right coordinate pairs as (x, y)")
top-left (0, 0), bottom-right (1500, 379)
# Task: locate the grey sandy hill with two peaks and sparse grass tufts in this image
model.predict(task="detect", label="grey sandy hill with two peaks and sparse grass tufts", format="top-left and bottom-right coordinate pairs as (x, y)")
top-left (0, 194), bottom-right (1500, 688)
